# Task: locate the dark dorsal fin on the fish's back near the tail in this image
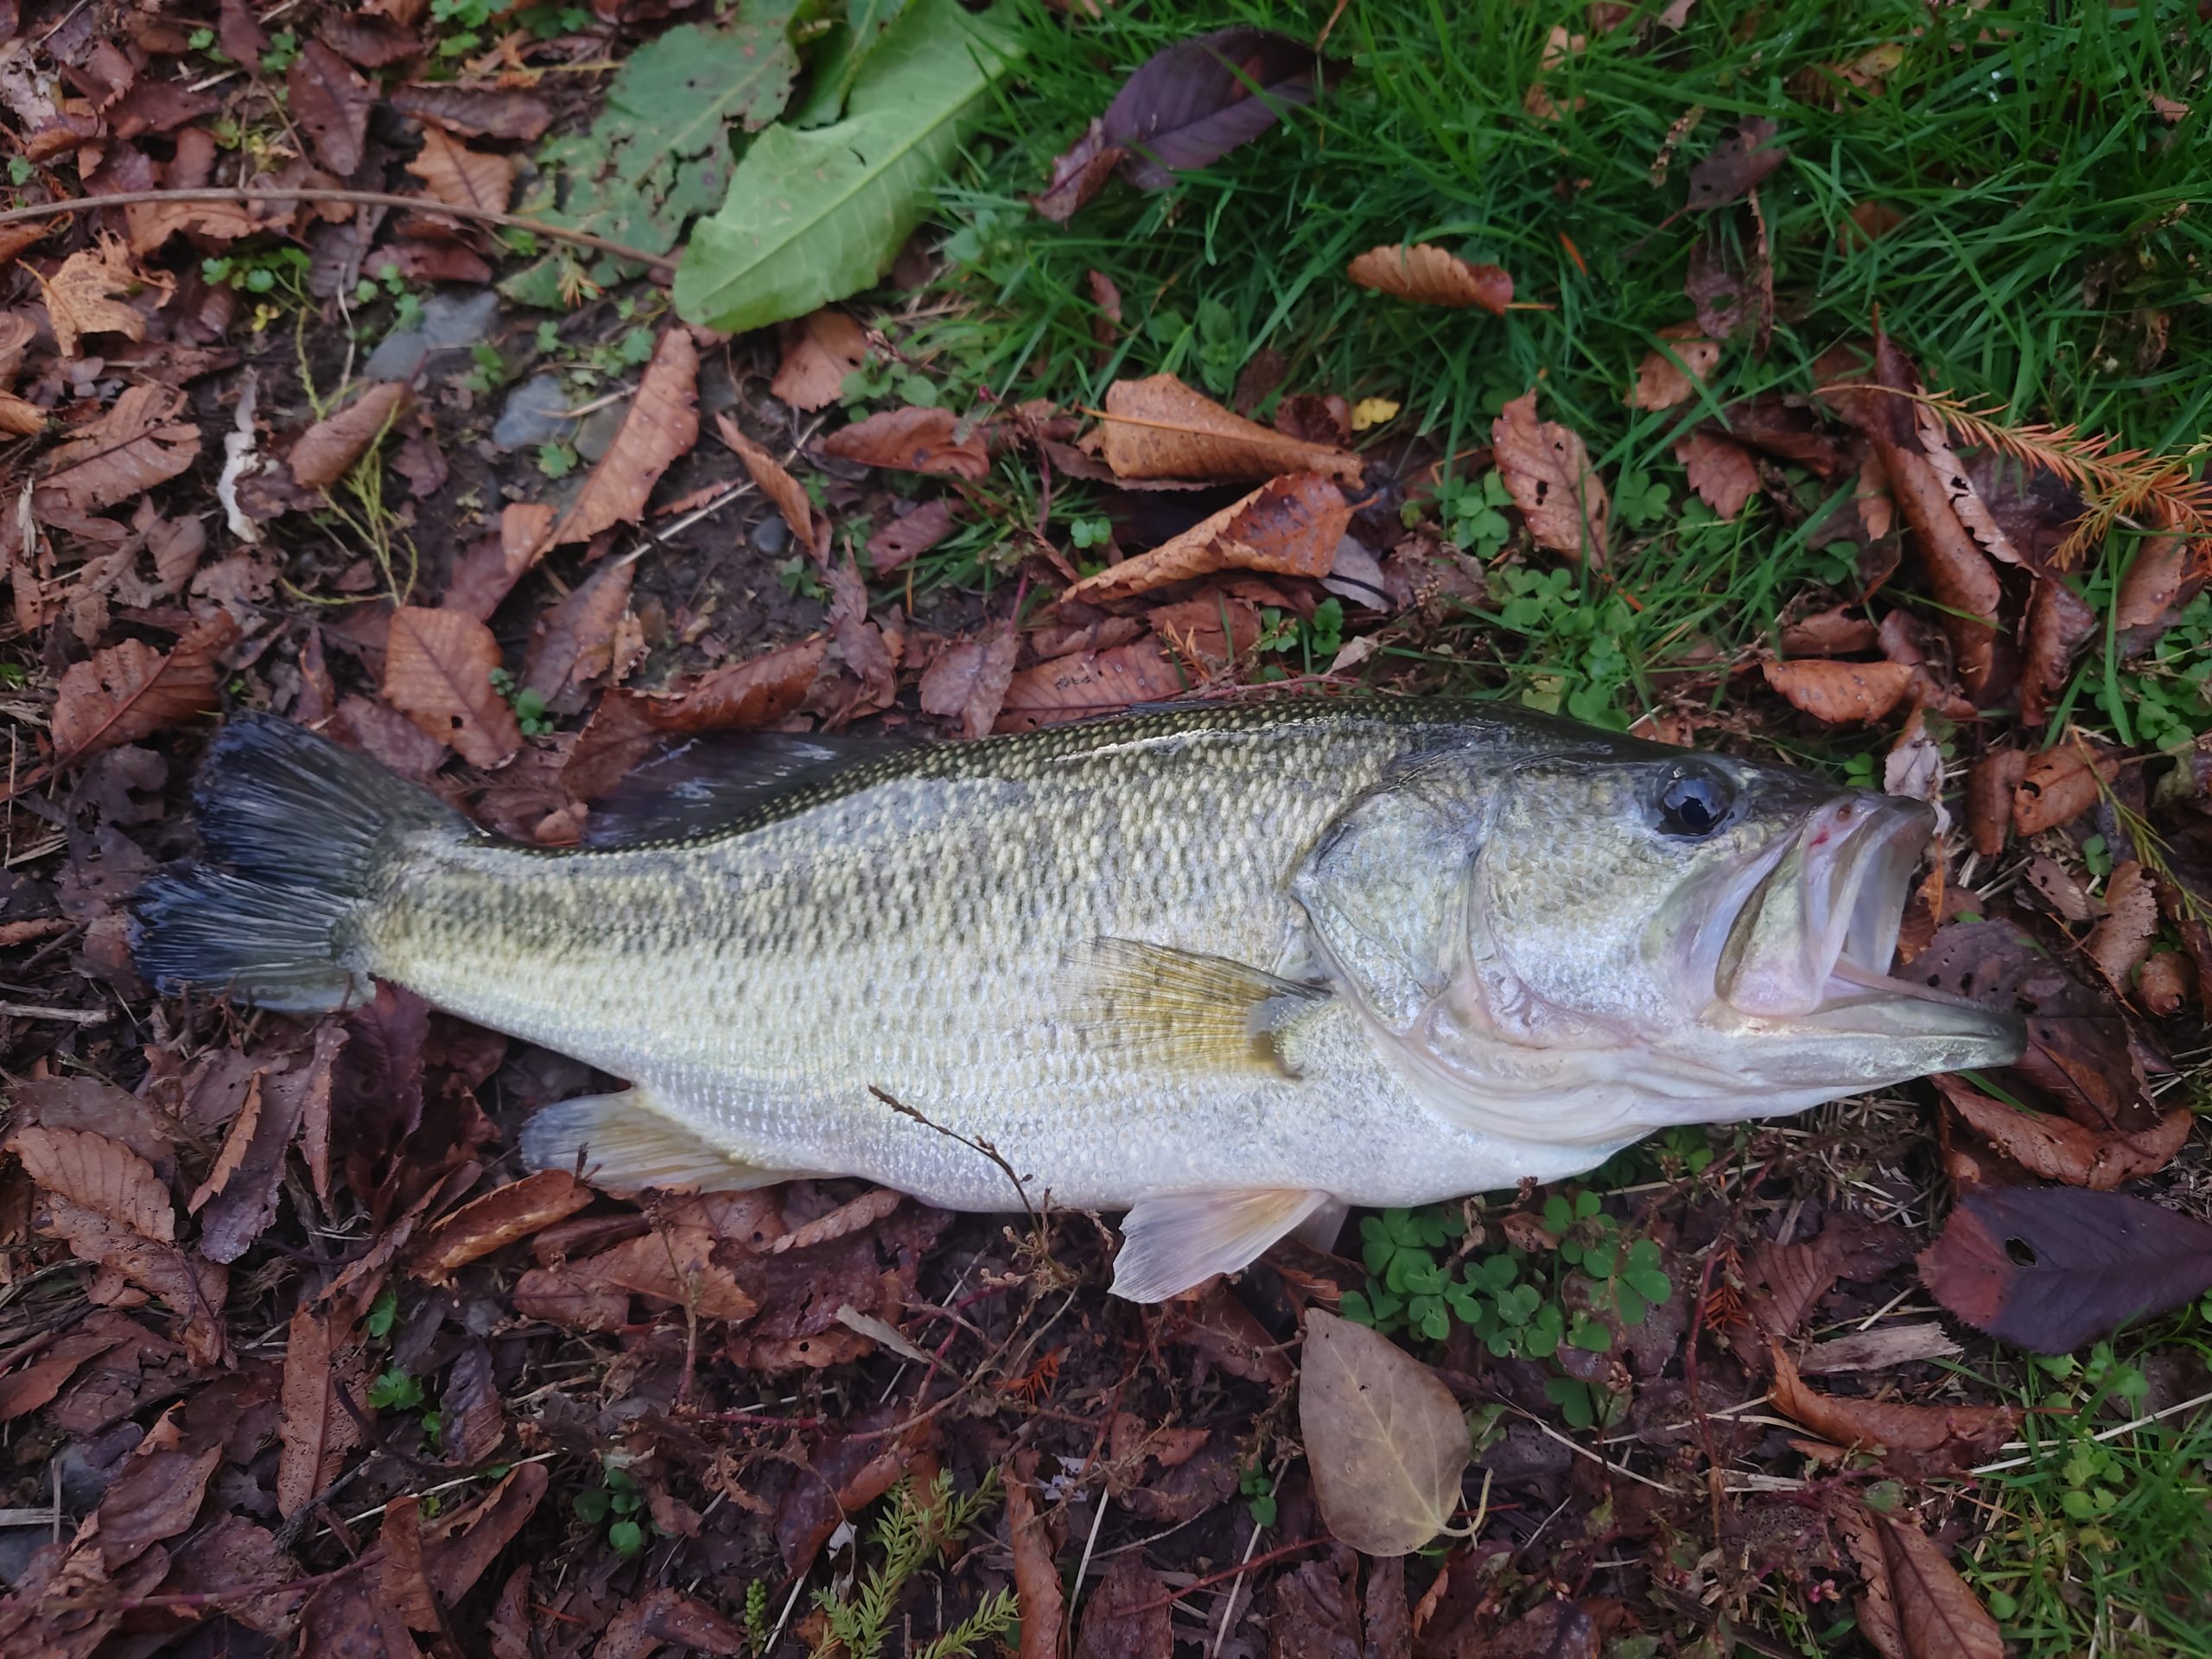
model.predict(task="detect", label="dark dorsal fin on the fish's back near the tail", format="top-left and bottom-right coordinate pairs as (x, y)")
top-left (584, 732), bottom-right (913, 847)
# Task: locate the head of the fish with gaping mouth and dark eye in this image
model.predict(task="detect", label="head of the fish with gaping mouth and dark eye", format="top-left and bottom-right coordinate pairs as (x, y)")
top-left (1300, 743), bottom-right (2024, 1146)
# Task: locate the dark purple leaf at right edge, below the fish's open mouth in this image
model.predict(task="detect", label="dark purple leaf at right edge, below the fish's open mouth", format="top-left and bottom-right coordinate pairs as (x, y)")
top-left (1920, 1188), bottom-right (2212, 1354)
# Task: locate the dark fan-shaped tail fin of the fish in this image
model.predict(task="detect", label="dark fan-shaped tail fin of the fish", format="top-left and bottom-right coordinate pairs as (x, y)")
top-left (130, 715), bottom-right (471, 1013)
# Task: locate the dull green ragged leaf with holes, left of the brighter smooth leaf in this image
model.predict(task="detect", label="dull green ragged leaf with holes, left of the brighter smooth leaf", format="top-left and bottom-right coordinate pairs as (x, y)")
top-left (500, 0), bottom-right (798, 308)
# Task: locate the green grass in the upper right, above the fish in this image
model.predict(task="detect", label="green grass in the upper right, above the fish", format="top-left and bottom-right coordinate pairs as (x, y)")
top-left (893, 0), bottom-right (2212, 759)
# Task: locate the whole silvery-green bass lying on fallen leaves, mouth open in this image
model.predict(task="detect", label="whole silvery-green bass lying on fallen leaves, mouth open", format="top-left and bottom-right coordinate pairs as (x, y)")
top-left (133, 696), bottom-right (2024, 1300)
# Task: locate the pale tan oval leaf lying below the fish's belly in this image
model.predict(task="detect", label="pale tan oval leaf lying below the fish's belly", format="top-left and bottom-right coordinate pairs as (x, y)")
top-left (1299, 1307), bottom-right (1473, 1555)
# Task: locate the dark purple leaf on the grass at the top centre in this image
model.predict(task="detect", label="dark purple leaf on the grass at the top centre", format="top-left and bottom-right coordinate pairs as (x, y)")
top-left (1102, 27), bottom-right (1325, 190)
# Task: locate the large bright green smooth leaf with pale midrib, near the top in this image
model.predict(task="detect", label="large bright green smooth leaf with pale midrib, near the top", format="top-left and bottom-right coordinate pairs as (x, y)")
top-left (677, 0), bottom-right (1015, 334)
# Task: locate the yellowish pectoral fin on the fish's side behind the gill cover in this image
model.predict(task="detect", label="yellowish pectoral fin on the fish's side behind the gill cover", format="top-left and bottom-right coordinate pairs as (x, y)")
top-left (1066, 938), bottom-right (1330, 1075)
